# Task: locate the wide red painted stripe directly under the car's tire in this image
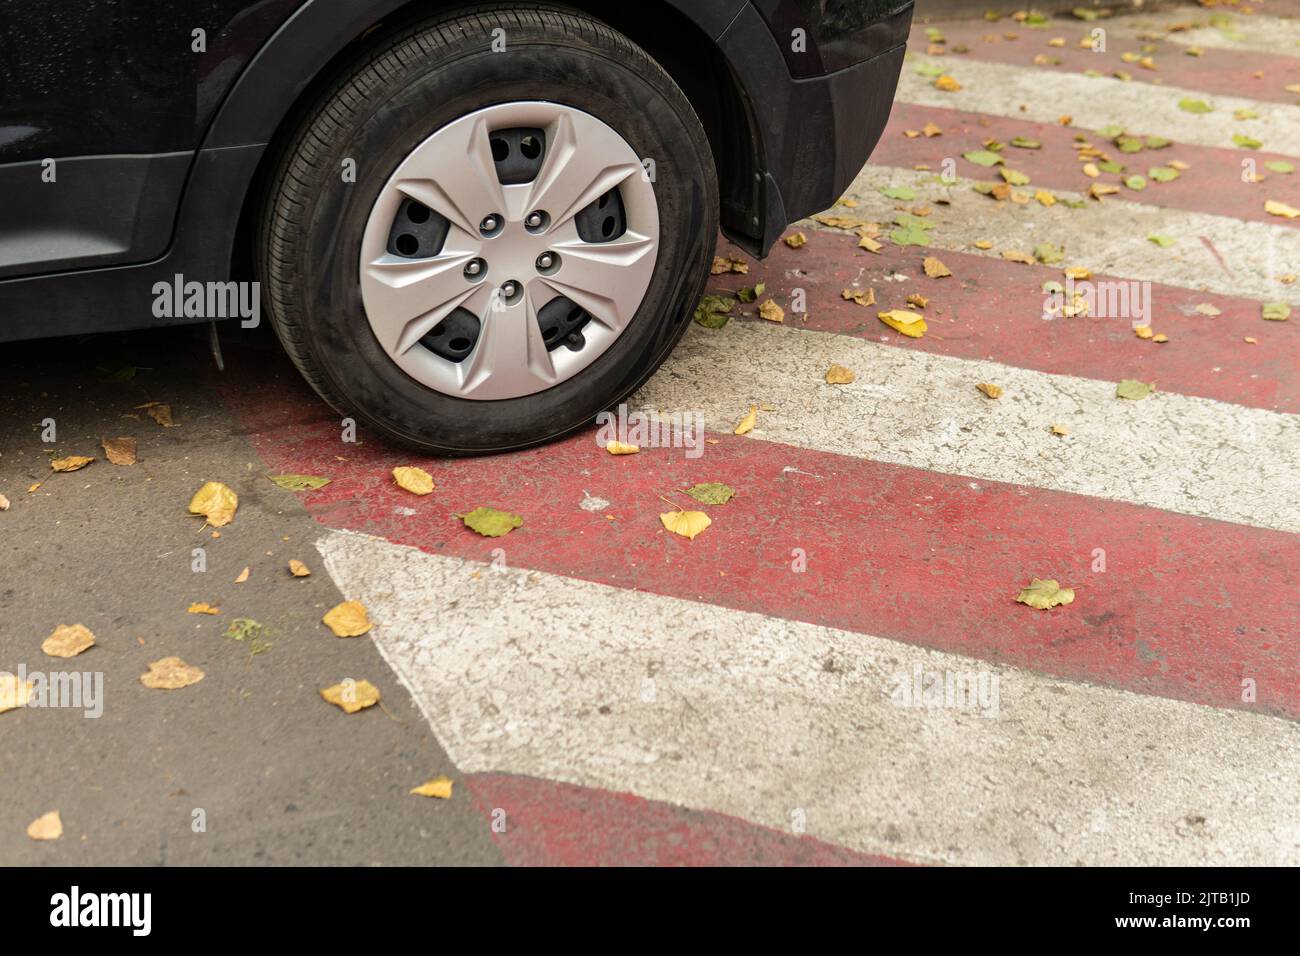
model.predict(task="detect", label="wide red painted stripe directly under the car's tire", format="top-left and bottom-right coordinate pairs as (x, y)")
top-left (221, 364), bottom-right (1300, 717)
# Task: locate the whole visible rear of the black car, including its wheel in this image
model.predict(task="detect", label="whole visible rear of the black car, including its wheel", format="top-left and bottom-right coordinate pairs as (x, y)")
top-left (0, 0), bottom-right (911, 453)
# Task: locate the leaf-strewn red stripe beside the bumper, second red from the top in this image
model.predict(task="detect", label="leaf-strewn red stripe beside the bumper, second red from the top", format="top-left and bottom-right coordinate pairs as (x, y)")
top-left (871, 103), bottom-right (1300, 229)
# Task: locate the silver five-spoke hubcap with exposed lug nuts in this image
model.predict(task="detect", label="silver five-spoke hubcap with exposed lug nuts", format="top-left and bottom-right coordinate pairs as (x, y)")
top-left (360, 103), bottom-right (659, 401)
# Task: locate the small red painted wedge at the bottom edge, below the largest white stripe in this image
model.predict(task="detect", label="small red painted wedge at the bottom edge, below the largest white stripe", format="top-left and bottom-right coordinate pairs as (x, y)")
top-left (464, 774), bottom-right (910, 866)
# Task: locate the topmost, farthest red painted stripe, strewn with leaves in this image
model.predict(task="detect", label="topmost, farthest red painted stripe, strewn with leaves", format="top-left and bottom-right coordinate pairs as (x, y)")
top-left (904, 14), bottom-right (1300, 103)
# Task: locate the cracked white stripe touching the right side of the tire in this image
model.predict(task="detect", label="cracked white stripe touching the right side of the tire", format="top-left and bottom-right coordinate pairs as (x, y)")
top-left (629, 319), bottom-right (1300, 531)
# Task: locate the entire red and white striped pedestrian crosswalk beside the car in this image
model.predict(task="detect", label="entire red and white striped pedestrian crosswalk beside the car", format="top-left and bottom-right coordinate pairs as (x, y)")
top-left (226, 1), bottom-right (1300, 865)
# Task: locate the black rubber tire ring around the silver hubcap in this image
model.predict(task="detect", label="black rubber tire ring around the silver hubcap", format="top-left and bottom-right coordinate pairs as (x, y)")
top-left (257, 1), bottom-right (718, 454)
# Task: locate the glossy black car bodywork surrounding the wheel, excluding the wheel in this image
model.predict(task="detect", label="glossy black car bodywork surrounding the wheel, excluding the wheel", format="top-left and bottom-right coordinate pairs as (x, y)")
top-left (0, 0), bottom-right (911, 341)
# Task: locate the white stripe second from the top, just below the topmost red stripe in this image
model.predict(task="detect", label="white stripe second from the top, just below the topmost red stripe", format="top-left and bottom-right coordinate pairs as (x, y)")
top-left (897, 56), bottom-right (1300, 157)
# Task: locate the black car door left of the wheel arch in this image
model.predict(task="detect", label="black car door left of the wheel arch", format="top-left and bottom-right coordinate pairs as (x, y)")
top-left (0, 0), bottom-right (300, 281)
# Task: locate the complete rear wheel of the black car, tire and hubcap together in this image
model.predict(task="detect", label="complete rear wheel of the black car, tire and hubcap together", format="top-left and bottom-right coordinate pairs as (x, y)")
top-left (259, 9), bottom-right (718, 454)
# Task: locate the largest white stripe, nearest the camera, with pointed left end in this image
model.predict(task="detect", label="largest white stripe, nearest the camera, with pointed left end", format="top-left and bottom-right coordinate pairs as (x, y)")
top-left (319, 533), bottom-right (1300, 865)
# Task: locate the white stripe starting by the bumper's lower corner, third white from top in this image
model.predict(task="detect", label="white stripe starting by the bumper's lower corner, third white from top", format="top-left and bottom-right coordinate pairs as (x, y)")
top-left (832, 165), bottom-right (1300, 308)
